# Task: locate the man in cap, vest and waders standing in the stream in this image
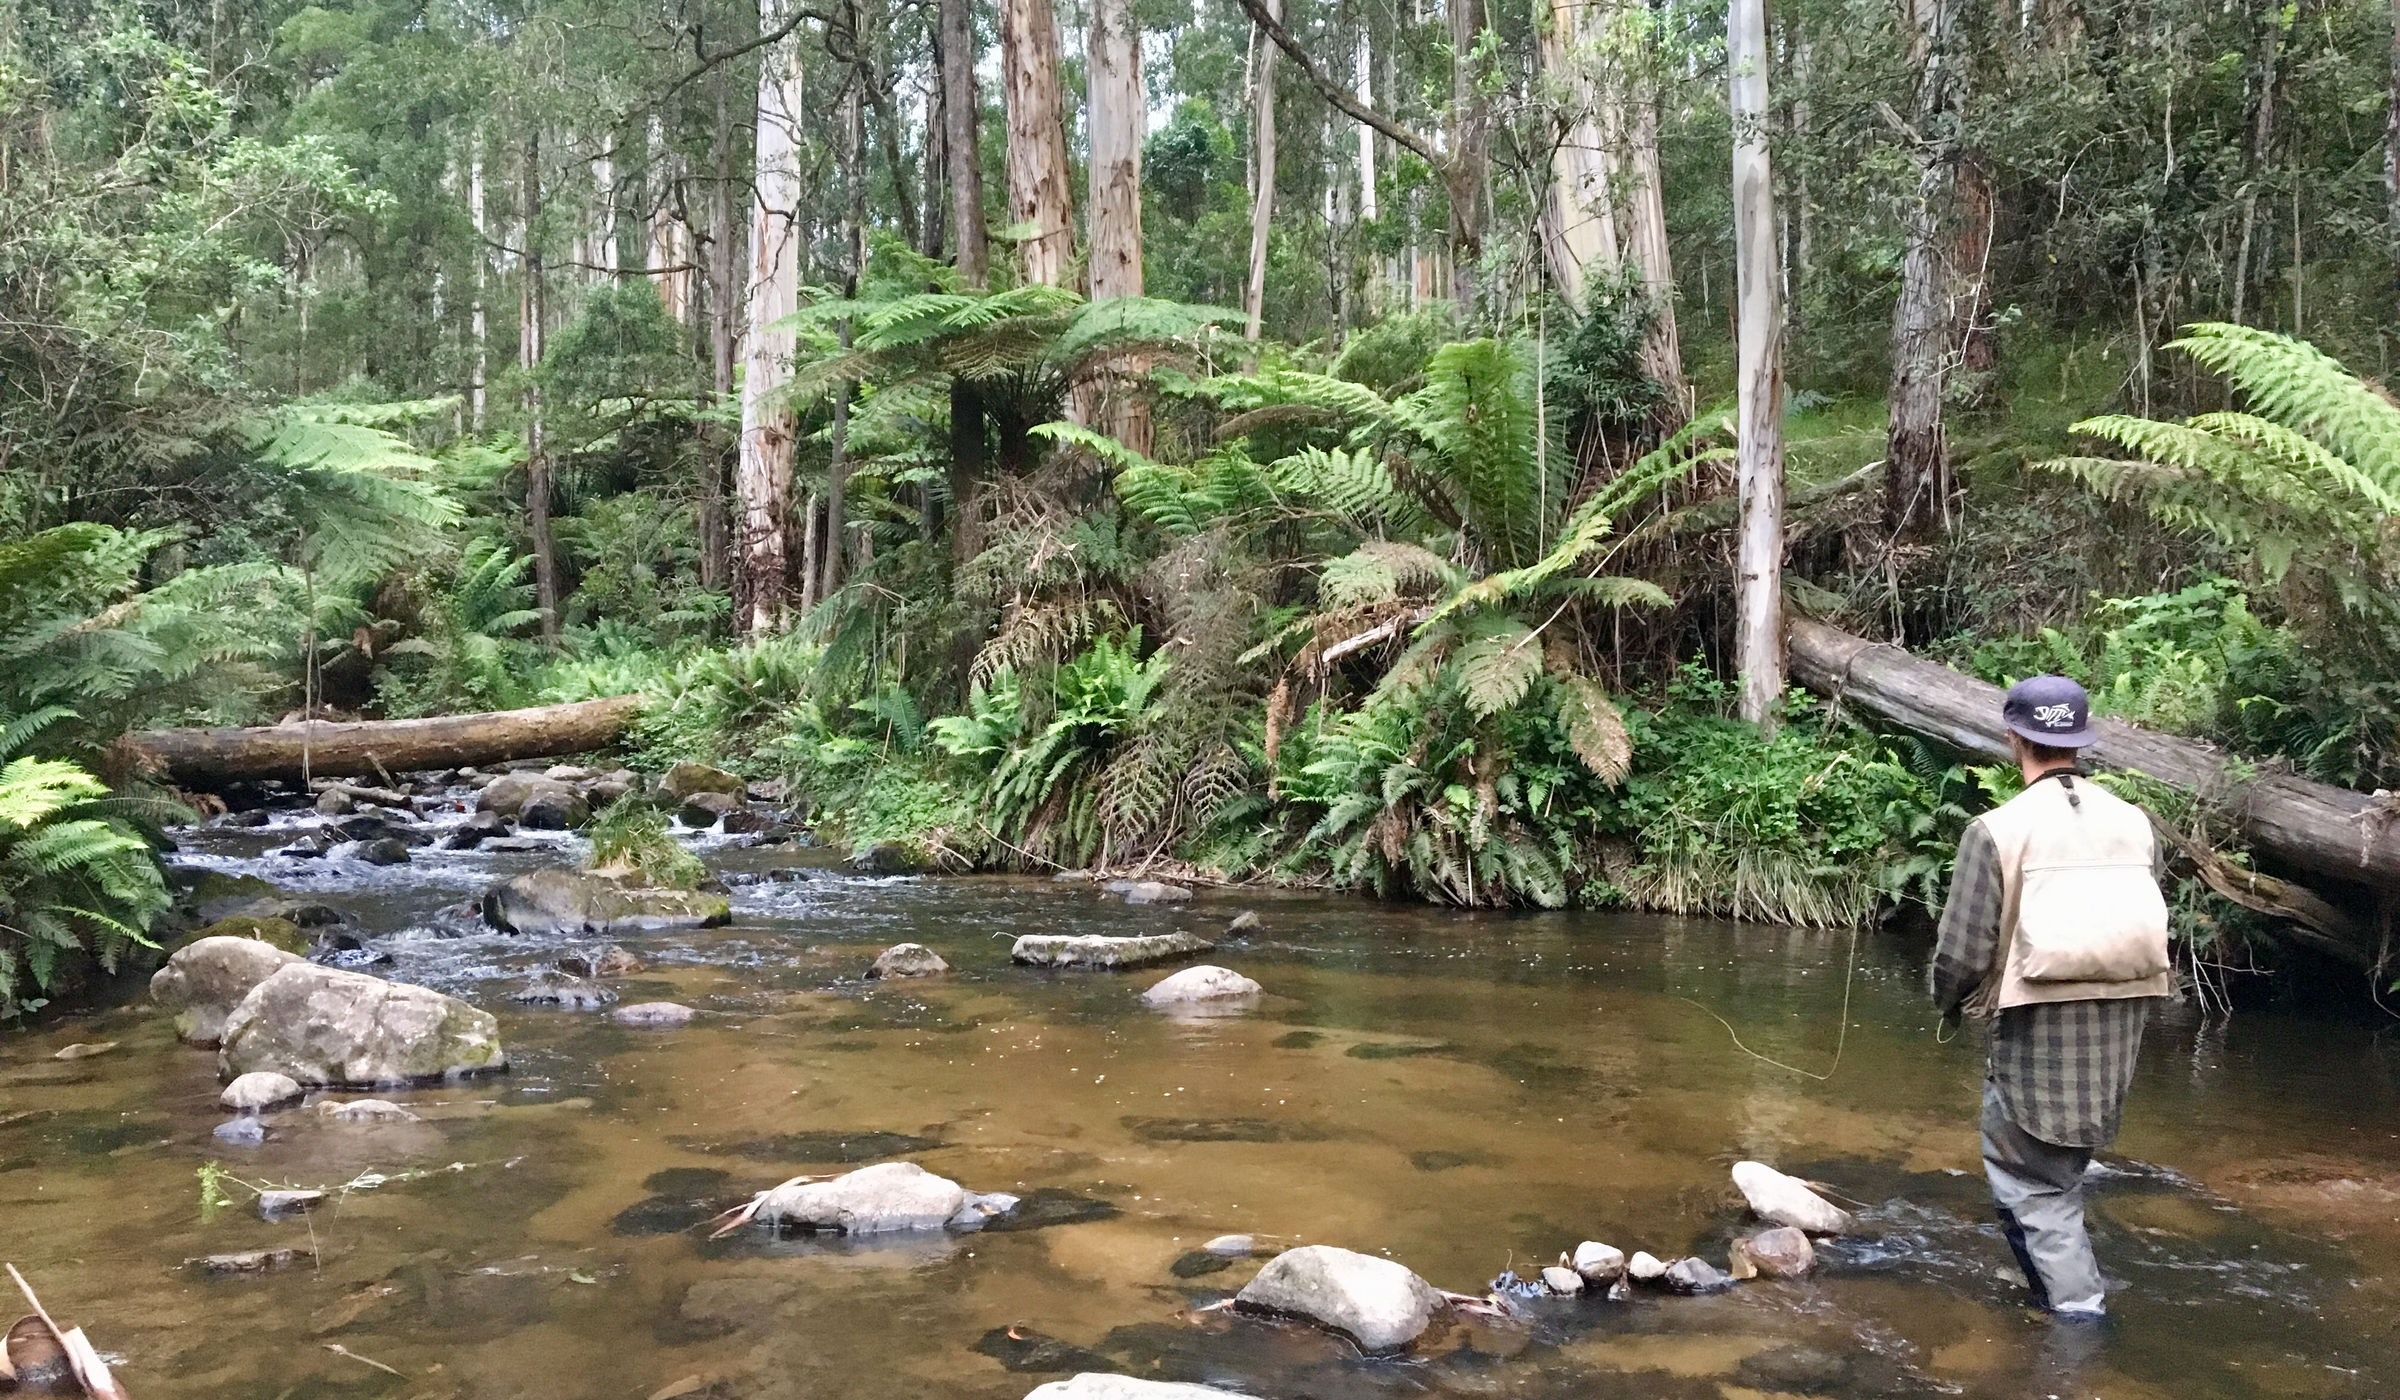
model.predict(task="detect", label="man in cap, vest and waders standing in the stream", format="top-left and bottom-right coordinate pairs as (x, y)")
top-left (1932, 675), bottom-right (2174, 1318)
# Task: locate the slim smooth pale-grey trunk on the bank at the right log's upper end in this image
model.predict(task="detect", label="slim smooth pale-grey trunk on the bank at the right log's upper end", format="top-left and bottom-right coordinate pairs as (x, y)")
top-left (1726, 0), bottom-right (1783, 725)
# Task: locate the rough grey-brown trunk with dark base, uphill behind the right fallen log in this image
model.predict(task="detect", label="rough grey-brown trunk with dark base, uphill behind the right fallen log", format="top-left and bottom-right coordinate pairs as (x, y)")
top-left (1884, 0), bottom-right (1958, 538)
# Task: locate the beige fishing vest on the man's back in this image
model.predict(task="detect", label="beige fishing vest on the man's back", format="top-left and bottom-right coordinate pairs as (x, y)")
top-left (1968, 778), bottom-right (2174, 1016)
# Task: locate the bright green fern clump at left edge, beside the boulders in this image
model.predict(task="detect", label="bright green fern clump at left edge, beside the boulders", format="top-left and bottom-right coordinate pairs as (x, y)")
top-left (0, 706), bottom-right (168, 1021)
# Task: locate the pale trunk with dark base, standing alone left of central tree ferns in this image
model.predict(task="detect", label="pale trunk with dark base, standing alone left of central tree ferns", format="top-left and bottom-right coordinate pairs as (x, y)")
top-left (734, 7), bottom-right (809, 636)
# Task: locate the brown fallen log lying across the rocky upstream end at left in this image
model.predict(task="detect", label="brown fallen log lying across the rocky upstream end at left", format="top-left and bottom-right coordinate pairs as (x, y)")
top-left (125, 694), bottom-right (641, 790)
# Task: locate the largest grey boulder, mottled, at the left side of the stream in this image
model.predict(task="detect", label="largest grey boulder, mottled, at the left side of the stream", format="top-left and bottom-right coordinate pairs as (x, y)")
top-left (216, 961), bottom-right (509, 1085)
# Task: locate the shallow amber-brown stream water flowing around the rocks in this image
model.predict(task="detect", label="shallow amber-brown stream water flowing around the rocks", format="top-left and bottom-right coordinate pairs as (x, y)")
top-left (0, 792), bottom-right (2400, 1400)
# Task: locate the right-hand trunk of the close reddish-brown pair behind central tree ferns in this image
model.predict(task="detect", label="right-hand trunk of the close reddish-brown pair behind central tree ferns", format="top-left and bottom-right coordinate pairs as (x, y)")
top-left (1085, 0), bottom-right (1152, 456)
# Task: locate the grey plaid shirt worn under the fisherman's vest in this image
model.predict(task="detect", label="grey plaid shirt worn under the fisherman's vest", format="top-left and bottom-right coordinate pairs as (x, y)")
top-left (1932, 824), bottom-right (2158, 1148)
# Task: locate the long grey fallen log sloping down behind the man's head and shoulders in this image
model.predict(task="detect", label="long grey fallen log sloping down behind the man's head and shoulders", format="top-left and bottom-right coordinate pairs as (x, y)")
top-left (1786, 612), bottom-right (2400, 907)
